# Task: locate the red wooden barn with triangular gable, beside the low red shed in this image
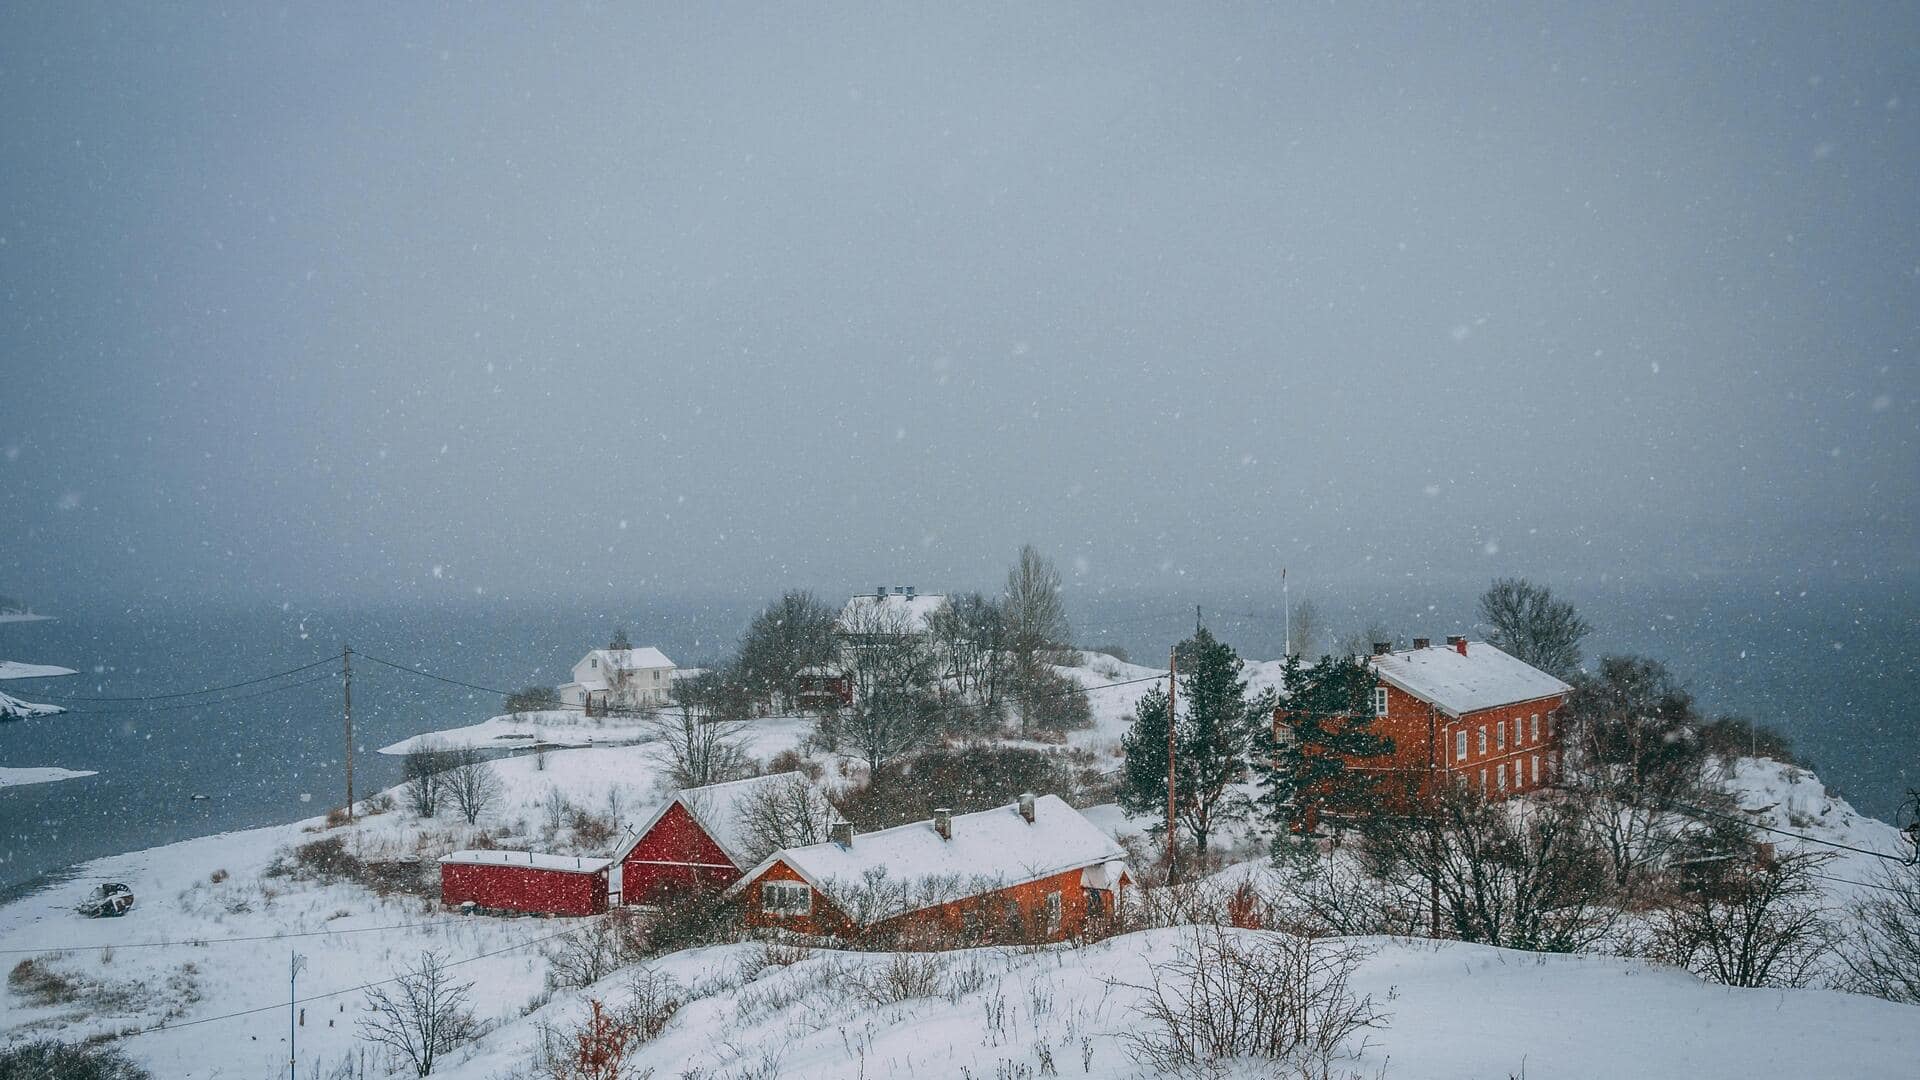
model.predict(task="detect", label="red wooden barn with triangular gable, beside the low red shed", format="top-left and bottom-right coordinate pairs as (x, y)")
top-left (612, 773), bottom-right (828, 903)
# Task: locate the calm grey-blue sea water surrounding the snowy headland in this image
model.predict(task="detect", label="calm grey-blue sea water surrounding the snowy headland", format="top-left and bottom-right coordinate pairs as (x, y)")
top-left (0, 580), bottom-right (1920, 892)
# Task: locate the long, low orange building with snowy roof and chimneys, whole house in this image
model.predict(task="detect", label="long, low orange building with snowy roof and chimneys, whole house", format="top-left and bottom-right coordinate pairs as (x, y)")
top-left (732, 796), bottom-right (1129, 942)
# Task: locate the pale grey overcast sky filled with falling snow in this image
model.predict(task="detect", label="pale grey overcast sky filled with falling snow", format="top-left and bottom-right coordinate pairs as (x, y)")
top-left (0, 2), bottom-right (1920, 603)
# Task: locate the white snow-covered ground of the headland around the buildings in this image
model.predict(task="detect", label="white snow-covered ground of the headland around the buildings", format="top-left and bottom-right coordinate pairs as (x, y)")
top-left (0, 657), bottom-right (1920, 1080)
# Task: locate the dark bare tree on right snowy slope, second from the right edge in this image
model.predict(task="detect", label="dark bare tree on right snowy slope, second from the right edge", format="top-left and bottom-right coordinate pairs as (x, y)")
top-left (1655, 819), bottom-right (1830, 986)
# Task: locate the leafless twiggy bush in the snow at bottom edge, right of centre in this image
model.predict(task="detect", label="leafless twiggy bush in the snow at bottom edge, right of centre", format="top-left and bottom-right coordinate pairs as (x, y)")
top-left (1121, 926), bottom-right (1386, 1076)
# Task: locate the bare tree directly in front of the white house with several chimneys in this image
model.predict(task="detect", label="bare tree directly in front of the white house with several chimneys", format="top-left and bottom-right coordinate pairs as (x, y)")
top-left (816, 605), bottom-right (945, 769)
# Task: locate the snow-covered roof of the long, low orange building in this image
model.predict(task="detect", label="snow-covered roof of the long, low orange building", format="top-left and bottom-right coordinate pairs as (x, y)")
top-left (733, 796), bottom-right (1125, 926)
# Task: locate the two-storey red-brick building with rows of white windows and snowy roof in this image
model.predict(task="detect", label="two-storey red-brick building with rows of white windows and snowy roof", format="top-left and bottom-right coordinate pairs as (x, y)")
top-left (1356, 638), bottom-right (1572, 799)
